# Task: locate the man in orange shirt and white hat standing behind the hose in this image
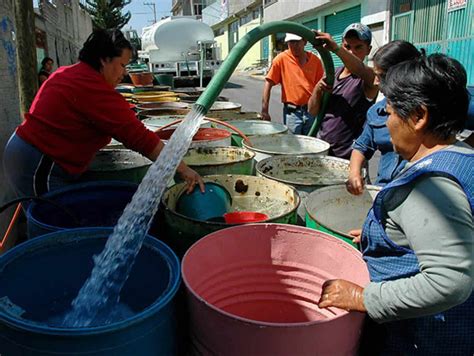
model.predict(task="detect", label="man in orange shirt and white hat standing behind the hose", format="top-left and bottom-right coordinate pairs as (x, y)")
top-left (262, 33), bottom-right (324, 135)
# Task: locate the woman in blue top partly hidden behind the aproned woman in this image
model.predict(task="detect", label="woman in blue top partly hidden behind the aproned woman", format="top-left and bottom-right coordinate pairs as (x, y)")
top-left (346, 40), bottom-right (421, 195)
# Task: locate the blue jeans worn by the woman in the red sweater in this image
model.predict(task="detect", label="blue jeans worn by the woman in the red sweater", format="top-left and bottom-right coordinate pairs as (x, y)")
top-left (3, 133), bottom-right (78, 198)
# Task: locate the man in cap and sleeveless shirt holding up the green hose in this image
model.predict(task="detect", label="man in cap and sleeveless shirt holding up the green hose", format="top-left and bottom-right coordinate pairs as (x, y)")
top-left (308, 23), bottom-right (378, 159)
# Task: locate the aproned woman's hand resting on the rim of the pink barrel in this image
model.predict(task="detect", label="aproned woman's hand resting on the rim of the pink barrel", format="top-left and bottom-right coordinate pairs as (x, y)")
top-left (318, 279), bottom-right (367, 312)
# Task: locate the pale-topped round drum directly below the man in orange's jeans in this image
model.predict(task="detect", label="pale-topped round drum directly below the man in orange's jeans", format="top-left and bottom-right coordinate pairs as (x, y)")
top-left (242, 134), bottom-right (330, 162)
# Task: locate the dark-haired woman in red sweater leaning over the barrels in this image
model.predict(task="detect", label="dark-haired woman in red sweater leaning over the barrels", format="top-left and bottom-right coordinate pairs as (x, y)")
top-left (4, 30), bottom-right (204, 196)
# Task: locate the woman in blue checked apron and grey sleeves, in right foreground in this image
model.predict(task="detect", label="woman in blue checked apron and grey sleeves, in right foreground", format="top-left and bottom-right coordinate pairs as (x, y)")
top-left (319, 54), bottom-right (474, 355)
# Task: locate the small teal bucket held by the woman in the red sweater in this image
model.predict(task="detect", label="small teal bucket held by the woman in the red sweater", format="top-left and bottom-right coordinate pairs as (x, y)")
top-left (176, 182), bottom-right (232, 221)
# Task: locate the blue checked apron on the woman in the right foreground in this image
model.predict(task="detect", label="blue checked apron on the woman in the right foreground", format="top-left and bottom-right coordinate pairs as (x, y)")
top-left (361, 150), bottom-right (474, 355)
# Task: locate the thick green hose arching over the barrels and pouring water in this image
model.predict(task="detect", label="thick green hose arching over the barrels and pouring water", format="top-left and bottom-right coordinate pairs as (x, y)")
top-left (196, 21), bottom-right (334, 136)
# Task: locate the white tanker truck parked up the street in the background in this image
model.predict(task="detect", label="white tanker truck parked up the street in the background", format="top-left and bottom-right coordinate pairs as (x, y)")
top-left (138, 16), bottom-right (221, 86)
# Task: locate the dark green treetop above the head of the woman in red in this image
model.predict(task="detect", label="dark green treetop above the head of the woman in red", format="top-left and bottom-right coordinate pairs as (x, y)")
top-left (84, 0), bottom-right (132, 29)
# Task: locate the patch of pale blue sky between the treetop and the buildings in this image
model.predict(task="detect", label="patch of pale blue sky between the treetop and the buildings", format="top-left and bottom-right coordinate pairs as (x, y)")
top-left (123, 0), bottom-right (171, 35)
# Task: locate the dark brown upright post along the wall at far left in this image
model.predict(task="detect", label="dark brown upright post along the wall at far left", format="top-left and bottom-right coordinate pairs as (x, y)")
top-left (14, 0), bottom-right (38, 117)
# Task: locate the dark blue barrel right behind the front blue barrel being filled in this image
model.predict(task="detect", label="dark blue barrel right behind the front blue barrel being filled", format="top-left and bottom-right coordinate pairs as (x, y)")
top-left (26, 181), bottom-right (158, 238)
